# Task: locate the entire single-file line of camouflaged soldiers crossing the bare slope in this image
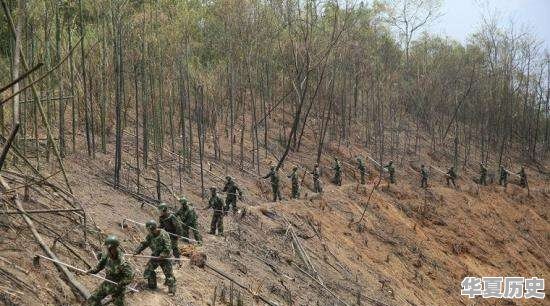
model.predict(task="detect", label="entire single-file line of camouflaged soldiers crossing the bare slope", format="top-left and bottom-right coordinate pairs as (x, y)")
top-left (86, 158), bottom-right (527, 306)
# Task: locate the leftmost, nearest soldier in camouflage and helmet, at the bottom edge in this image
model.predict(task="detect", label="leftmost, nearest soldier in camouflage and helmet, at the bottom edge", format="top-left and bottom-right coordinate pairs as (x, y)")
top-left (86, 235), bottom-right (134, 306)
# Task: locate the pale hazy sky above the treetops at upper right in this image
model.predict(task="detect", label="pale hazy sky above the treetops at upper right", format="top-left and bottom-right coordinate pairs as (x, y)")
top-left (431, 0), bottom-right (550, 49)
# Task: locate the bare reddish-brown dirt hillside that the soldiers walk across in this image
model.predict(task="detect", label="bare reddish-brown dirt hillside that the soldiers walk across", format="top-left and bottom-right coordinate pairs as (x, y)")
top-left (2, 121), bottom-right (550, 305)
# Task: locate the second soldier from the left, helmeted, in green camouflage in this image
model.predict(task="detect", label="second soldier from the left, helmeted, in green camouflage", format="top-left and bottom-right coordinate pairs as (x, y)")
top-left (134, 220), bottom-right (176, 294)
